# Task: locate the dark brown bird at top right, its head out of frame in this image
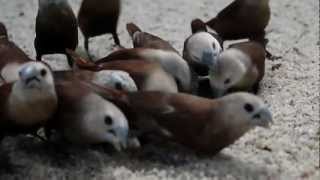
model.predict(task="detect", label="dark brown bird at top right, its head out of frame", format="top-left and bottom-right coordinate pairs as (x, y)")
top-left (206, 0), bottom-right (272, 58)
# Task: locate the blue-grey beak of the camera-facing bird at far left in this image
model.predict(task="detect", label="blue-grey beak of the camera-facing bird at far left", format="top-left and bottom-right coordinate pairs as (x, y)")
top-left (19, 65), bottom-right (40, 88)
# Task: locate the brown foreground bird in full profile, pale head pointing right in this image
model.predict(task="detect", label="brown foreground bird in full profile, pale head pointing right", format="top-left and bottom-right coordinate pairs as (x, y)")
top-left (85, 87), bottom-right (272, 154)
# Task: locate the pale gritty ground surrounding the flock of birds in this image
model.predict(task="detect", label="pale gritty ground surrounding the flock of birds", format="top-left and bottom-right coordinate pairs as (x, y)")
top-left (0, 0), bottom-right (320, 180)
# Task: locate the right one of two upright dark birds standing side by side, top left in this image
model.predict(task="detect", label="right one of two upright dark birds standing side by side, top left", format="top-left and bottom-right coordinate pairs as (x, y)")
top-left (78, 0), bottom-right (121, 52)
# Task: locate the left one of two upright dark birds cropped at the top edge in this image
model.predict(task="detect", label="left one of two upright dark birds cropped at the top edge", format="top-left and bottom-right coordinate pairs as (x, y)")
top-left (34, 0), bottom-right (78, 67)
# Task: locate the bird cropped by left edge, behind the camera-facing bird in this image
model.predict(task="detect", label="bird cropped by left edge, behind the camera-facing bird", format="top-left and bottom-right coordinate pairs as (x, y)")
top-left (0, 22), bottom-right (31, 83)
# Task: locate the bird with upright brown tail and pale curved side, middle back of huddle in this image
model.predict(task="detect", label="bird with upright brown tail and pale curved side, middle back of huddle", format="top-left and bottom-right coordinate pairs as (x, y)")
top-left (125, 23), bottom-right (195, 92)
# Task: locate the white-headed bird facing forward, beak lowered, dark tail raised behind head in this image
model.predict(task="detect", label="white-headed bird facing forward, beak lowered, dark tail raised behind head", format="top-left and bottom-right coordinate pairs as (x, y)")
top-left (183, 19), bottom-right (223, 76)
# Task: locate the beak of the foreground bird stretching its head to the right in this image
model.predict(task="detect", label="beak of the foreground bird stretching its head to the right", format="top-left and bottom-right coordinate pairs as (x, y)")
top-left (253, 107), bottom-right (273, 129)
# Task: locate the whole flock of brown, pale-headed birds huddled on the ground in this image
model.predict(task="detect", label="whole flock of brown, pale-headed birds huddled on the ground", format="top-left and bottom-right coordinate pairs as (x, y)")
top-left (0, 0), bottom-right (275, 172)
